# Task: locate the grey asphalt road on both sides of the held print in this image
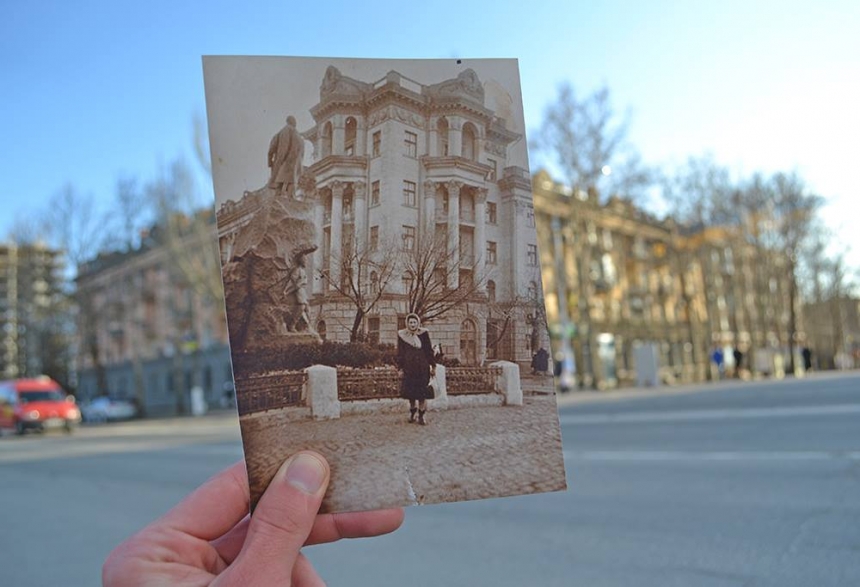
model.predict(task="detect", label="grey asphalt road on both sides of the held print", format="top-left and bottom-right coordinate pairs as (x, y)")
top-left (0, 373), bottom-right (860, 587)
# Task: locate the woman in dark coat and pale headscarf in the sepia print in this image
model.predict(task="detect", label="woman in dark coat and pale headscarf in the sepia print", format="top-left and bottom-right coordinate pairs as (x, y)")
top-left (397, 314), bottom-right (436, 424)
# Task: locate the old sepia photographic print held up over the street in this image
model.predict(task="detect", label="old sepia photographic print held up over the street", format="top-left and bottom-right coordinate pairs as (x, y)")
top-left (204, 57), bottom-right (566, 512)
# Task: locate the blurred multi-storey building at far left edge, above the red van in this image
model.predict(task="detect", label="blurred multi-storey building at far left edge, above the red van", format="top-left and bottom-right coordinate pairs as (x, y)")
top-left (0, 243), bottom-right (69, 384)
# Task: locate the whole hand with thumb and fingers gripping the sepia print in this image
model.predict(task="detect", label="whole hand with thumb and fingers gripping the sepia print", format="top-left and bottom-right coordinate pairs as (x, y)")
top-left (102, 452), bottom-right (403, 587)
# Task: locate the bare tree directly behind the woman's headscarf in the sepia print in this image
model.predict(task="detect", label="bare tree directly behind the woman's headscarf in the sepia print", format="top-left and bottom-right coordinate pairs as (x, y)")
top-left (399, 230), bottom-right (488, 322)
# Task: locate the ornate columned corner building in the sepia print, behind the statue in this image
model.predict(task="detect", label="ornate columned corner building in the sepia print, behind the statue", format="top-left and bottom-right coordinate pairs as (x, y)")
top-left (218, 67), bottom-right (548, 365)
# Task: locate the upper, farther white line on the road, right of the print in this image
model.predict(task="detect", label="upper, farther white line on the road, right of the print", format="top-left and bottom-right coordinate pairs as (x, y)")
top-left (559, 404), bottom-right (860, 425)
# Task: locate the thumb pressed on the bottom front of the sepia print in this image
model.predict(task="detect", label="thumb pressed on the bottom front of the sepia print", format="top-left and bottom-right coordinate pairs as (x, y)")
top-left (222, 451), bottom-right (330, 585)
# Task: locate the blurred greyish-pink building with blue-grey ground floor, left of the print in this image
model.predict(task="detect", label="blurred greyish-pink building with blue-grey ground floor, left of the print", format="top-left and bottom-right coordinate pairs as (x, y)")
top-left (76, 220), bottom-right (232, 416)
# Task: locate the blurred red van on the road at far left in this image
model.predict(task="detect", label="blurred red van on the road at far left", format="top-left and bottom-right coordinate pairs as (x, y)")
top-left (0, 376), bottom-right (81, 434)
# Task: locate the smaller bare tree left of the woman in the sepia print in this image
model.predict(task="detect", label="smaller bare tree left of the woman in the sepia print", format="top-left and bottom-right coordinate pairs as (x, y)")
top-left (319, 237), bottom-right (399, 342)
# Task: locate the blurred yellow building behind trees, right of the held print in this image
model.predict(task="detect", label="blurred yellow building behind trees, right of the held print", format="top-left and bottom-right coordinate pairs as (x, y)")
top-left (533, 171), bottom-right (802, 388)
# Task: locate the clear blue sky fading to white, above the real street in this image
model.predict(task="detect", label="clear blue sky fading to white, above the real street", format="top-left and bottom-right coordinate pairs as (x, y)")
top-left (0, 0), bottom-right (860, 268)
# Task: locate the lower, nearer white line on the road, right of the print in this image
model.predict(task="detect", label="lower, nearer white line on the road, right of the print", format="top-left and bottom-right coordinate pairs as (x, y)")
top-left (564, 450), bottom-right (860, 462)
